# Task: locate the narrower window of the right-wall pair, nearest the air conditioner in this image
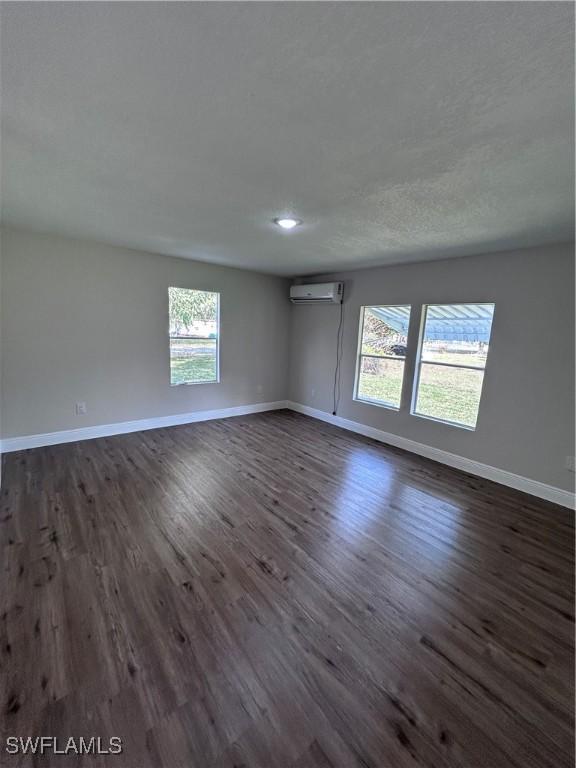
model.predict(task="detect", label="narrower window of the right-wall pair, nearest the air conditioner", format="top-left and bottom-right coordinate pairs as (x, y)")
top-left (355, 306), bottom-right (410, 409)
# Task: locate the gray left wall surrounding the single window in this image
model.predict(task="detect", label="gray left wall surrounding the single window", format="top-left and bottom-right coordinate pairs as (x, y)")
top-left (1, 229), bottom-right (290, 438)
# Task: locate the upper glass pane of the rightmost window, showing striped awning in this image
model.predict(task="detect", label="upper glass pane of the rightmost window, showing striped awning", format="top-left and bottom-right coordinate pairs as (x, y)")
top-left (421, 304), bottom-right (494, 368)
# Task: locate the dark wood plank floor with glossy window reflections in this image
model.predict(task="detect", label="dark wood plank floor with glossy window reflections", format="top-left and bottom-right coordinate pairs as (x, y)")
top-left (0, 411), bottom-right (574, 768)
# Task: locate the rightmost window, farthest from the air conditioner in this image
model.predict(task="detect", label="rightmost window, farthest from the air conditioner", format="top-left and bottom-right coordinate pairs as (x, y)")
top-left (412, 304), bottom-right (494, 429)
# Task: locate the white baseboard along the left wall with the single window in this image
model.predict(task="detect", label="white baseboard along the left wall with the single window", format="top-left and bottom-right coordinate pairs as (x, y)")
top-left (0, 400), bottom-right (288, 453)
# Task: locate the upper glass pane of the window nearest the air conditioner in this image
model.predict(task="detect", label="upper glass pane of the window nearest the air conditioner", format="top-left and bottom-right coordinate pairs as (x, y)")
top-left (362, 306), bottom-right (410, 357)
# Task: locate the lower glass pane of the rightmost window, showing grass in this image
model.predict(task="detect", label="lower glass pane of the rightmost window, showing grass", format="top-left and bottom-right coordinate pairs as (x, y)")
top-left (415, 363), bottom-right (484, 427)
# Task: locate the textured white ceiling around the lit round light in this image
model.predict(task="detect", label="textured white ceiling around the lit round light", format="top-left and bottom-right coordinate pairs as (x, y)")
top-left (2, 2), bottom-right (574, 275)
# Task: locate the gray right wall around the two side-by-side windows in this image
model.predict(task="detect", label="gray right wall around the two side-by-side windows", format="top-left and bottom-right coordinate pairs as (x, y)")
top-left (290, 245), bottom-right (574, 490)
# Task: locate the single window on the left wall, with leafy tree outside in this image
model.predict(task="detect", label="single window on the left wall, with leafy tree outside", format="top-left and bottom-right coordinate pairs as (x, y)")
top-left (168, 288), bottom-right (220, 384)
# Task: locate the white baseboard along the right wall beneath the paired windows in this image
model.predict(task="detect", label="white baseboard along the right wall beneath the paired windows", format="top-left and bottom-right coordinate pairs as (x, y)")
top-left (286, 401), bottom-right (574, 509)
